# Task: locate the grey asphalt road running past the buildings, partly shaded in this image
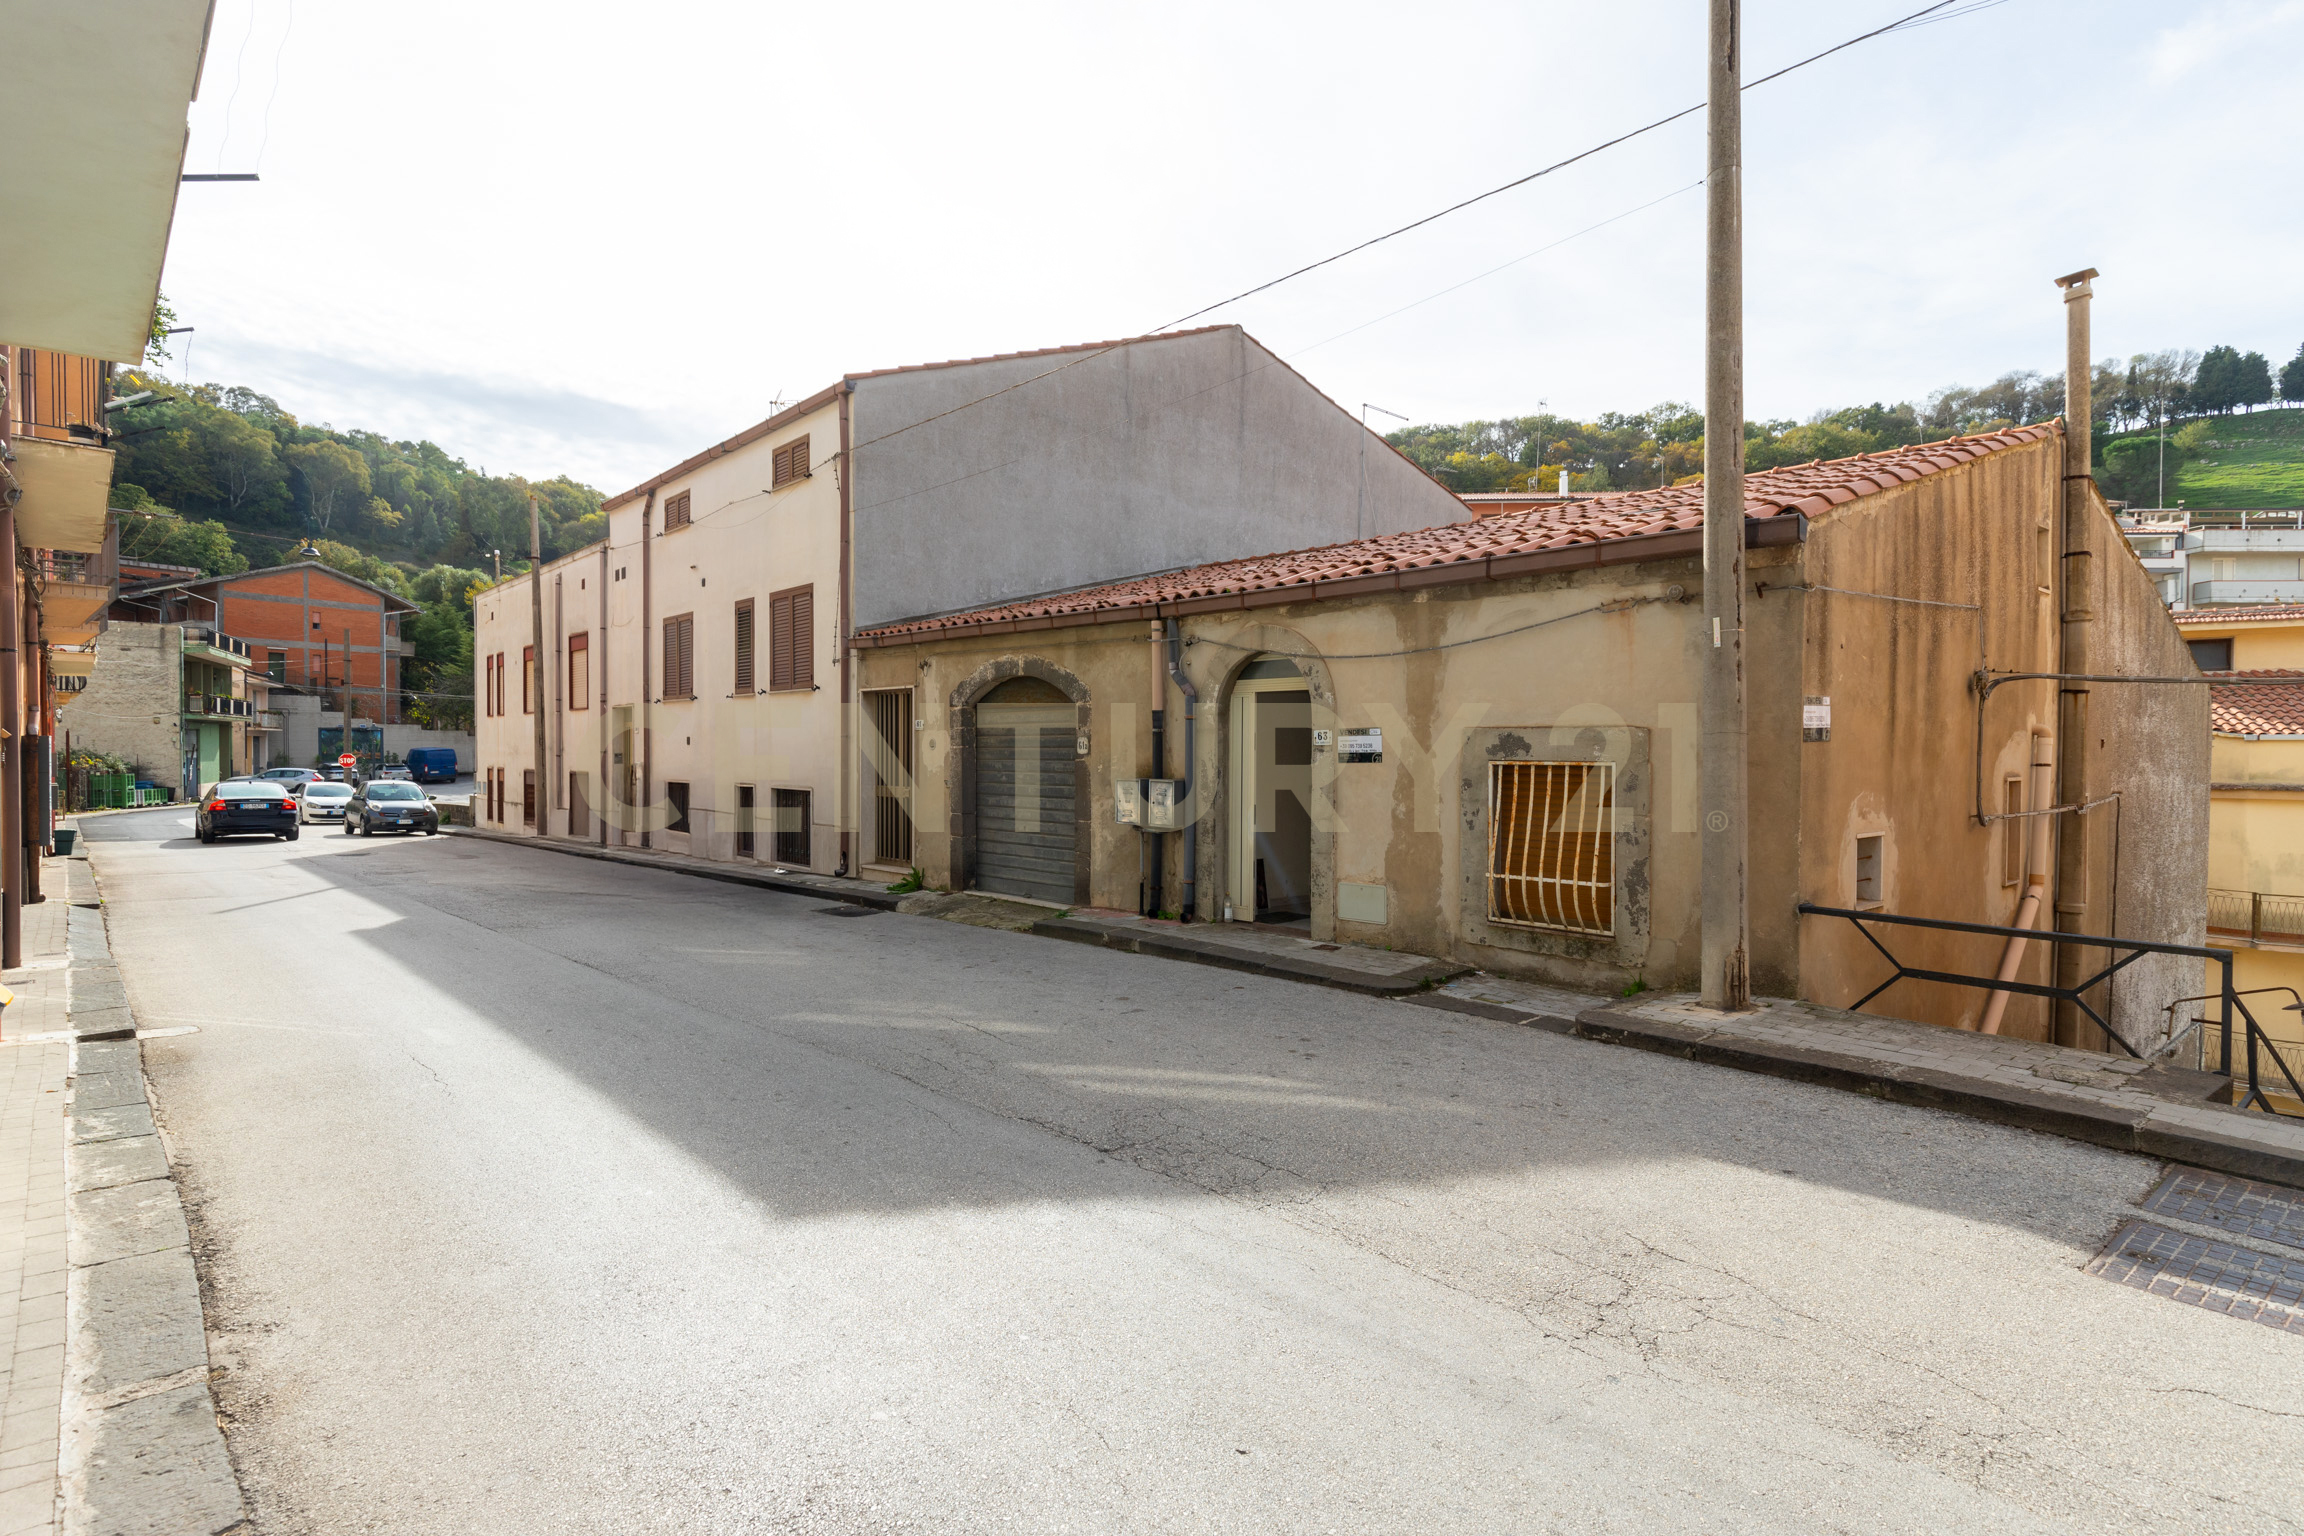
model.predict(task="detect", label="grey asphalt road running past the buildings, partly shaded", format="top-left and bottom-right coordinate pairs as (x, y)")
top-left (85, 808), bottom-right (2304, 1536)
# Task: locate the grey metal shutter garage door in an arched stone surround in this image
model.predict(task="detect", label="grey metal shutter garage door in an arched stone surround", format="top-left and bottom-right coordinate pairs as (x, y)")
top-left (977, 679), bottom-right (1081, 905)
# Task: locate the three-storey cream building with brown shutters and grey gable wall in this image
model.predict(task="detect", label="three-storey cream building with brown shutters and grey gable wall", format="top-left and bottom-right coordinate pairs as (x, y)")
top-left (472, 325), bottom-right (1468, 873)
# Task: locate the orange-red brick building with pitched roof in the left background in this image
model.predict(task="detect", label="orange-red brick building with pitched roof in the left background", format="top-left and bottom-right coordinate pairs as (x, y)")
top-left (113, 560), bottom-right (417, 725)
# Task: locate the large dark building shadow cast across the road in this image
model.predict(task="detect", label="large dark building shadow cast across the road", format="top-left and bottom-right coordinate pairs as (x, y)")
top-left (283, 836), bottom-right (2152, 1239)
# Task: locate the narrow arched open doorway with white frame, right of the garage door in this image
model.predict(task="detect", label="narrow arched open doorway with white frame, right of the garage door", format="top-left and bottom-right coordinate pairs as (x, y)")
top-left (1228, 656), bottom-right (1311, 923)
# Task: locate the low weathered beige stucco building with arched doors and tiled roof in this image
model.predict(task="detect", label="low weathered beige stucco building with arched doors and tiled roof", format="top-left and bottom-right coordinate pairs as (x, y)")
top-left (857, 426), bottom-right (2207, 1045)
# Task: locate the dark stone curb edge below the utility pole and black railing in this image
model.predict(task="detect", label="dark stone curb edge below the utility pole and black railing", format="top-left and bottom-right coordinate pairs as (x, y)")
top-left (1382, 995), bottom-right (2304, 1188)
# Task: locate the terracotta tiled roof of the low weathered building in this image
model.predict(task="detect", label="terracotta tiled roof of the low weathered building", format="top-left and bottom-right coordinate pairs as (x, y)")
top-left (857, 421), bottom-right (2062, 642)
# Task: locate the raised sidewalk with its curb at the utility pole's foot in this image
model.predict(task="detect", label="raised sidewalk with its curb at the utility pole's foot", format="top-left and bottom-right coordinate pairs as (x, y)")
top-left (1415, 976), bottom-right (2304, 1186)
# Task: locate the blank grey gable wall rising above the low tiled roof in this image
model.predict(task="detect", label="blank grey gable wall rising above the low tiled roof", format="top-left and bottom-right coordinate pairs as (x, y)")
top-left (847, 327), bottom-right (1470, 629)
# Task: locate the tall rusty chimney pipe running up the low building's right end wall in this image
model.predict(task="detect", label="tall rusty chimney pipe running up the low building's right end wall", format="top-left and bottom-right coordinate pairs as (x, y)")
top-left (2053, 267), bottom-right (2097, 1045)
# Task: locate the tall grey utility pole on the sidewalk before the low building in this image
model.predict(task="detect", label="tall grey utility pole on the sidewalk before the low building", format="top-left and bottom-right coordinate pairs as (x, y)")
top-left (1695, 0), bottom-right (1751, 1013)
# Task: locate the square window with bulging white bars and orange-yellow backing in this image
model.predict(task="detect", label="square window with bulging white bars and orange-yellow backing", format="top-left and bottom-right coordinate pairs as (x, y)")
top-left (1488, 762), bottom-right (1615, 933)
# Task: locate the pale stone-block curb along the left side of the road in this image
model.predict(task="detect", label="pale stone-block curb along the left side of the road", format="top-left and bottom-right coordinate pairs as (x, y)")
top-left (58, 870), bottom-right (247, 1536)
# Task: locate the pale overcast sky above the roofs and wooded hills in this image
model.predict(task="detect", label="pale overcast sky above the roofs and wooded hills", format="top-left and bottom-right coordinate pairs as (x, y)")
top-left (153, 0), bottom-right (2304, 491)
